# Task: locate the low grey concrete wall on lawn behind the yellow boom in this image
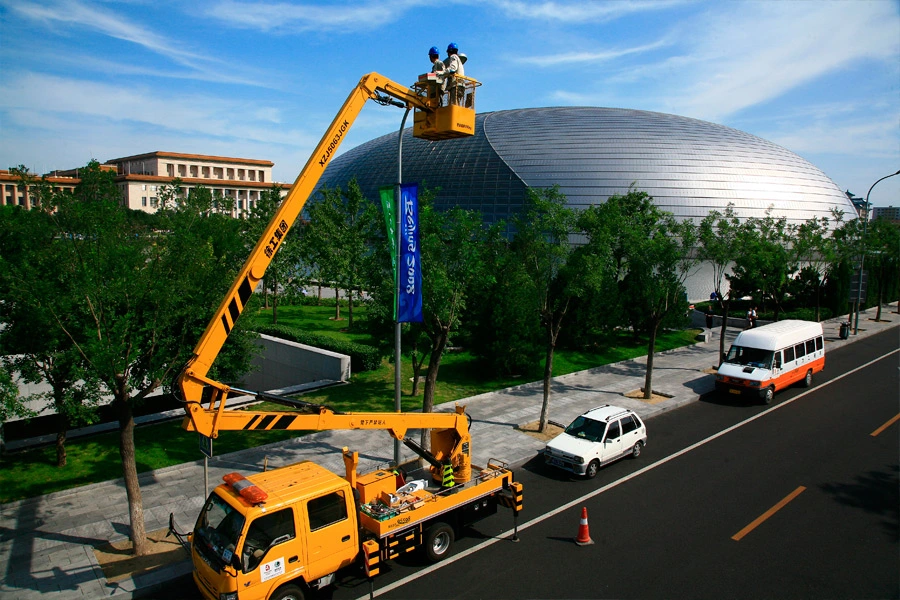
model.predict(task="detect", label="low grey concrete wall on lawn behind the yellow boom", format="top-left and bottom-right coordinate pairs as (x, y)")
top-left (241, 335), bottom-right (350, 390)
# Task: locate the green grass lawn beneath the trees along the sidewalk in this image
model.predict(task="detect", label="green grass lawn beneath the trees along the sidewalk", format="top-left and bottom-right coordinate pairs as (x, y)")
top-left (0, 306), bottom-right (697, 503)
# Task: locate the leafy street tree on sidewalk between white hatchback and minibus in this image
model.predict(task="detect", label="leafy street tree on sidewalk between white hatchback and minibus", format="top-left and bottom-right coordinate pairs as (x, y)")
top-left (603, 187), bottom-right (696, 400)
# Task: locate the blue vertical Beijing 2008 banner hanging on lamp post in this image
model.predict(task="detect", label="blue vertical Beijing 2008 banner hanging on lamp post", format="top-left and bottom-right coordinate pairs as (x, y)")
top-left (397, 183), bottom-right (422, 323)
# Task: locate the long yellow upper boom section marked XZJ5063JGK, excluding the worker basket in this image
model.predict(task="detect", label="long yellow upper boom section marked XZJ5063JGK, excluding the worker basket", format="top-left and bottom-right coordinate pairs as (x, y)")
top-left (178, 73), bottom-right (436, 408)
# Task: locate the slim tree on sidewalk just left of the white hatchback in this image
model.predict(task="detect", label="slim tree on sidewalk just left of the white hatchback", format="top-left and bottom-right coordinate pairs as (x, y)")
top-left (511, 186), bottom-right (579, 432)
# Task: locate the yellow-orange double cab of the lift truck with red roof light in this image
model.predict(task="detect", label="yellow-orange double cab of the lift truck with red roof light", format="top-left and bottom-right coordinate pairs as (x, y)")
top-left (191, 462), bottom-right (359, 600)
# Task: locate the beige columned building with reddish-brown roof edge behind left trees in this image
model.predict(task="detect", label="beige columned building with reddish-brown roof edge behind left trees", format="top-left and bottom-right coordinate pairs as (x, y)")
top-left (0, 152), bottom-right (290, 217)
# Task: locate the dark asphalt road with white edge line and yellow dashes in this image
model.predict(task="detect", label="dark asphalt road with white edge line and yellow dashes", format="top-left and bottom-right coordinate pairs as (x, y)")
top-left (162, 331), bottom-right (900, 599)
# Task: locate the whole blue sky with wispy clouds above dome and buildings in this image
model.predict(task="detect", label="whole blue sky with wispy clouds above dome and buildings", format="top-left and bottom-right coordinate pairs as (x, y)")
top-left (0, 0), bottom-right (900, 206)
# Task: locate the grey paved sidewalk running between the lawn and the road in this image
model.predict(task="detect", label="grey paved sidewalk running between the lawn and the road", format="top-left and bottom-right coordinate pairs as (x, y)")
top-left (0, 304), bottom-right (900, 600)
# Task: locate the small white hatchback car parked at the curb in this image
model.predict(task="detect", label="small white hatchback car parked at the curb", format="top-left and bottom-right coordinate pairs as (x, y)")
top-left (544, 404), bottom-right (647, 478)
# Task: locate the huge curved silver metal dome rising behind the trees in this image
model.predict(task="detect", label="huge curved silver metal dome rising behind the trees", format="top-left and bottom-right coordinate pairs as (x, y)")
top-left (320, 107), bottom-right (856, 229)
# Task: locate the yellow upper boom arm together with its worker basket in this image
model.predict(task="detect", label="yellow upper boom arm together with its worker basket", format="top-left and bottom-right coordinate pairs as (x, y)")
top-left (177, 73), bottom-right (480, 418)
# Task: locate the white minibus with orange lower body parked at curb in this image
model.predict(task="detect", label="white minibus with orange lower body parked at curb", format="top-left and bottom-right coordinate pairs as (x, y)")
top-left (716, 320), bottom-right (825, 404)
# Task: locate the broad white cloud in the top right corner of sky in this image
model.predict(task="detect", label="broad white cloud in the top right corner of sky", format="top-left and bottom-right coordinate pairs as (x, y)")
top-left (660, 2), bottom-right (900, 120)
